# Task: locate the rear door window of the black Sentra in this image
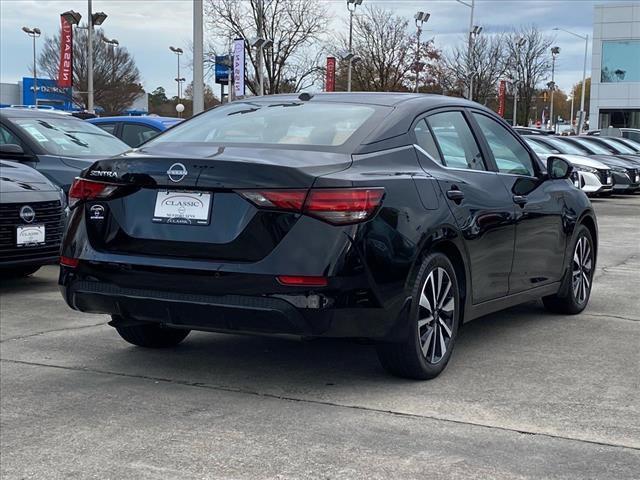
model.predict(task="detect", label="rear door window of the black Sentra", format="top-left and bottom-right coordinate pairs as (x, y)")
top-left (427, 112), bottom-right (486, 170)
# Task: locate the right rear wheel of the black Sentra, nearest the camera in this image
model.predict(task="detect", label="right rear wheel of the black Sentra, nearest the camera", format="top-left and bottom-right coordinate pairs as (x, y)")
top-left (377, 252), bottom-right (460, 380)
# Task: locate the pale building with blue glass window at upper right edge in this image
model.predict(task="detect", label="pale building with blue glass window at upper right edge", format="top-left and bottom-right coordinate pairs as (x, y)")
top-left (589, 2), bottom-right (640, 129)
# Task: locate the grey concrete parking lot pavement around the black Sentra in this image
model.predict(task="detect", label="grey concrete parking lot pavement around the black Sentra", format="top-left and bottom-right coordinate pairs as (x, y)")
top-left (0, 195), bottom-right (640, 479)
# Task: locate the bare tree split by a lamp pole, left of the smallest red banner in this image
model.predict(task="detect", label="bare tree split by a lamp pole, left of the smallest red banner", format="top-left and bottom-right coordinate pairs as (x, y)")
top-left (438, 34), bottom-right (508, 105)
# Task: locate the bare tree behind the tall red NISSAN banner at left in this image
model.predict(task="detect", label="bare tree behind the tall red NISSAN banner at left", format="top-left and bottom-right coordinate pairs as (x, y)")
top-left (38, 25), bottom-right (144, 113)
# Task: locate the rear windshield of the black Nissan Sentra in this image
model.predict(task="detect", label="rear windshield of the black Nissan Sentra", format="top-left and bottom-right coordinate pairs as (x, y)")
top-left (145, 101), bottom-right (376, 146)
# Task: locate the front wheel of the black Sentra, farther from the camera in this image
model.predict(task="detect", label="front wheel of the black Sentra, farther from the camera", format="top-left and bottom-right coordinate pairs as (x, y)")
top-left (542, 225), bottom-right (595, 315)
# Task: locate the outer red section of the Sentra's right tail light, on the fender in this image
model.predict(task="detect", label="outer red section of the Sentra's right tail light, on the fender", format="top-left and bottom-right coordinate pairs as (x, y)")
top-left (304, 188), bottom-right (384, 225)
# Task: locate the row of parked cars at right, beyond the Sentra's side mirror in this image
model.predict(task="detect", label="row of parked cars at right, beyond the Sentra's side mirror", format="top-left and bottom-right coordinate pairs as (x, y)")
top-left (519, 129), bottom-right (640, 196)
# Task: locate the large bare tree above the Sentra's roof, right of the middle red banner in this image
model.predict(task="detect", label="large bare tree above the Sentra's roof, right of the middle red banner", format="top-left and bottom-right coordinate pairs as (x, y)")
top-left (332, 6), bottom-right (438, 92)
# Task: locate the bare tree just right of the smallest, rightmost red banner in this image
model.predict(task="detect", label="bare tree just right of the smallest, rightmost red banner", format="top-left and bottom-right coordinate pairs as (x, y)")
top-left (506, 25), bottom-right (553, 125)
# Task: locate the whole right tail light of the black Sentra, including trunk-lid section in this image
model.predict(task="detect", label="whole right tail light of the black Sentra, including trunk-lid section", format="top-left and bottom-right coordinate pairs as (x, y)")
top-left (237, 187), bottom-right (384, 225)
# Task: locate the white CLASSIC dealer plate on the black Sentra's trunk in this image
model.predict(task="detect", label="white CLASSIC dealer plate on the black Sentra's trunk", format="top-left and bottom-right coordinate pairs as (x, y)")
top-left (152, 190), bottom-right (213, 226)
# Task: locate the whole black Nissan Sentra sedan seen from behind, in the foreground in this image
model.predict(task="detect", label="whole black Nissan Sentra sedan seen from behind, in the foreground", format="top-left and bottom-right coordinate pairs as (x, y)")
top-left (60, 93), bottom-right (598, 379)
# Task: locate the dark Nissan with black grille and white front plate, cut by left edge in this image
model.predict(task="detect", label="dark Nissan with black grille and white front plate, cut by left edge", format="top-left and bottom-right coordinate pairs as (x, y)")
top-left (0, 160), bottom-right (66, 278)
